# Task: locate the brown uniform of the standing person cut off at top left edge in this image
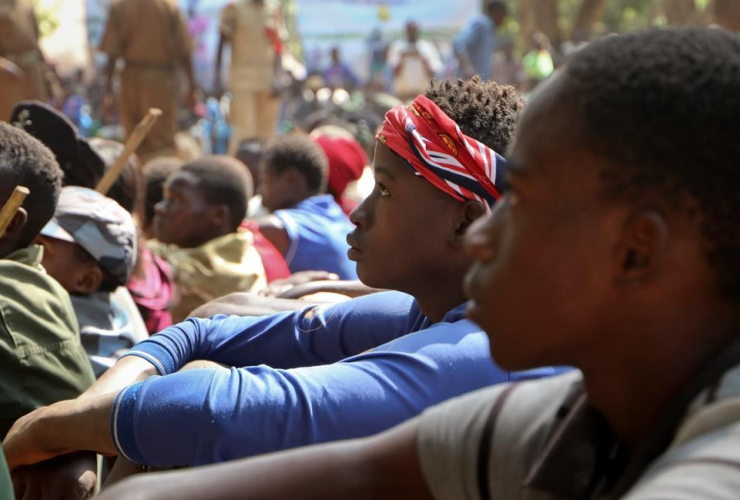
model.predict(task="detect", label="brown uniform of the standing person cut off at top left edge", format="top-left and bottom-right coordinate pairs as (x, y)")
top-left (0, 0), bottom-right (48, 121)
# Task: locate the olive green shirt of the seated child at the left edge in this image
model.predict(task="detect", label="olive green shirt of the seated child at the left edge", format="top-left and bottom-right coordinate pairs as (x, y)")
top-left (0, 246), bottom-right (95, 439)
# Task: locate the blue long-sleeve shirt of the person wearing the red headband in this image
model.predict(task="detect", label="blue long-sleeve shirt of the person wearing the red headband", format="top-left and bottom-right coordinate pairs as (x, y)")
top-left (111, 292), bottom-right (558, 467)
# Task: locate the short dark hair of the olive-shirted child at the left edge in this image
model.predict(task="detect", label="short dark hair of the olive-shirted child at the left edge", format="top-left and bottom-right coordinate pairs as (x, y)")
top-left (0, 122), bottom-right (63, 248)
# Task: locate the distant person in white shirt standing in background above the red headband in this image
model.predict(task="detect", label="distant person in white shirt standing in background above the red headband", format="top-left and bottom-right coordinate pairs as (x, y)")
top-left (388, 21), bottom-right (442, 101)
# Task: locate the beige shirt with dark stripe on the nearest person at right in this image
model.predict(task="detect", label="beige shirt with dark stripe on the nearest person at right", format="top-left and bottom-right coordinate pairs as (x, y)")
top-left (418, 367), bottom-right (740, 500)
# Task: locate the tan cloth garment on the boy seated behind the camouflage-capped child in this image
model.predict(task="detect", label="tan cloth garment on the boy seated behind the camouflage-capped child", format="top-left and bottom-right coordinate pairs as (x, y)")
top-left (149, 231), bottom-right (267, 323)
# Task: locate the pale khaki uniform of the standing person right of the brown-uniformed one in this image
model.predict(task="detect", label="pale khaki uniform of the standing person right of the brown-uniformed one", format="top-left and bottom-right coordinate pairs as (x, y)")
top-left (219, 0), bottom-right (282, 154)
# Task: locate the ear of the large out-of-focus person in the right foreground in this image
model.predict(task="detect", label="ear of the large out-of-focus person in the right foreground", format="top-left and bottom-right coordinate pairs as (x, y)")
top-left (615, 210), bottom-right (670, 285)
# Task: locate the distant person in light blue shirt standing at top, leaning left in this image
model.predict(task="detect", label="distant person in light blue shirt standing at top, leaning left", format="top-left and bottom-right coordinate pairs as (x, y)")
top-left (452, 0), bottom-right (509, 80)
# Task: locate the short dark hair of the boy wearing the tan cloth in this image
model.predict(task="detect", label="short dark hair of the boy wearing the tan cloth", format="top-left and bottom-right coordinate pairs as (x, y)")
top-left (179, 156), bottom-right (253, 231)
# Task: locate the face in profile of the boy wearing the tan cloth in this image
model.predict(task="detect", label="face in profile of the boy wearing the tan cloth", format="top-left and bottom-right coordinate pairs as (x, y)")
top-left (153, 171), bottom-right (213, 248)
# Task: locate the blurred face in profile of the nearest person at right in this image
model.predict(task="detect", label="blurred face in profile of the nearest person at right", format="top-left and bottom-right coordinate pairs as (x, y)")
top-left (466, 75), bottom-right (621, 370)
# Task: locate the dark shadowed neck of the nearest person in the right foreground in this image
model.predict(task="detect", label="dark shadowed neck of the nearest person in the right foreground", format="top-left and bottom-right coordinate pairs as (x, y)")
top-left (576, 308), bottom-right (736, 451)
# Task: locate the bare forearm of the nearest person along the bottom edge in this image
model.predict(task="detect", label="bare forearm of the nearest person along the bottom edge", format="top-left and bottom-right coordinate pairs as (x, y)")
top-left (101, 422), bottom-right (431, 500)
